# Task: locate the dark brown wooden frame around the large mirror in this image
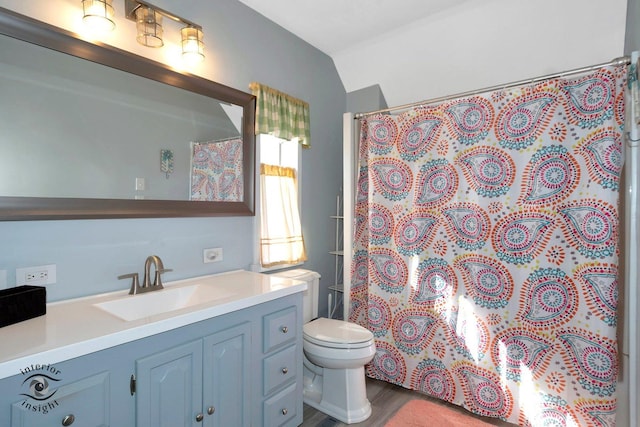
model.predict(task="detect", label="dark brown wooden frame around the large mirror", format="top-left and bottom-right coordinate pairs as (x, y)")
top-left (0, 7), bottom-right (256, 221)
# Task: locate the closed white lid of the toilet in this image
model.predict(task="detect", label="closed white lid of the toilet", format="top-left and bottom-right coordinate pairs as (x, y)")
top-left (302, 317), bottom-right (373, 348)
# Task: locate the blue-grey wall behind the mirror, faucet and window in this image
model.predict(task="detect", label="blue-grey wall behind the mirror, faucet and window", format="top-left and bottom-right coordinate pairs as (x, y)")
top-left (0, 0), bottom-right (346, 314)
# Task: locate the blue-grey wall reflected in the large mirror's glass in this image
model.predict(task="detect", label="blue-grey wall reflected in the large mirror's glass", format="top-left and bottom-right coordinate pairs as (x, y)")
top-left (0, 37), bottom-right (242, 201)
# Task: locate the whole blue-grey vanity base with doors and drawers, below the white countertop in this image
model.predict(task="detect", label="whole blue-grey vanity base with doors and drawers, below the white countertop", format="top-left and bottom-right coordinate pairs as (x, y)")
top-left (0, 292), bottom-right (303, 427)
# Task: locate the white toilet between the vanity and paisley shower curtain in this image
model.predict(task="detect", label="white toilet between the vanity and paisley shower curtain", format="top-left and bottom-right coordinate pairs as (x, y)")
top-left (274, 269), bottom-right (376, 424)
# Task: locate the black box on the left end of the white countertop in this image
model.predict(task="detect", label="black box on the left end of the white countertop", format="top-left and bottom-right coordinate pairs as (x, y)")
top-left (0, 285), bottom-right (47, 327)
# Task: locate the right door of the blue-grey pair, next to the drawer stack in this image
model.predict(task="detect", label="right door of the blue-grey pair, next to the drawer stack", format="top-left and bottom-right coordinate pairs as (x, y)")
top-left (203, 322), bottom-right (250, 427)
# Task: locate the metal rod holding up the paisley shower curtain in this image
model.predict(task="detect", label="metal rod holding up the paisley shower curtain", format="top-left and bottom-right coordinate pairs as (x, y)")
top-left (353, 56), bottom-right (631, 120)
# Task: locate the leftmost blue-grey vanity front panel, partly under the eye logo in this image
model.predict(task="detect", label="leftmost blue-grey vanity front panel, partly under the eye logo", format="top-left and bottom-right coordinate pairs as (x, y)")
top-left (11, 372), bottom-right (110, 427)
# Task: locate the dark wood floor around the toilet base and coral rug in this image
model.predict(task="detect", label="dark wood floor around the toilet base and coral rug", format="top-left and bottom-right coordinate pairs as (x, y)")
top-left (302, 378), bottom-right (513, 427)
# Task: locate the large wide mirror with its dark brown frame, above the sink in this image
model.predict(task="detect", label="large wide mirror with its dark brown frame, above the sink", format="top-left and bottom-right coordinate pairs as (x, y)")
top-left (0, 8), bottom-right (255, 220)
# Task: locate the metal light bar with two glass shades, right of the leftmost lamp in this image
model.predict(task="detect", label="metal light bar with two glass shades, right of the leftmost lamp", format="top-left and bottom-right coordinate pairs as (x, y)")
top-left (124, 0), bottom-right (204, 64)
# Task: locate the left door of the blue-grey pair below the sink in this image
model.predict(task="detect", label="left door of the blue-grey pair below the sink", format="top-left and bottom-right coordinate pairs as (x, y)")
top-left (136, 340), bottom-right (202, 427)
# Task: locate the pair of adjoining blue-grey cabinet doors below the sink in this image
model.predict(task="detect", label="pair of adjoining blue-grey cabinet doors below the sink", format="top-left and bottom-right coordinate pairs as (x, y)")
top-left (136, 323), bottom-right (251, 427)
